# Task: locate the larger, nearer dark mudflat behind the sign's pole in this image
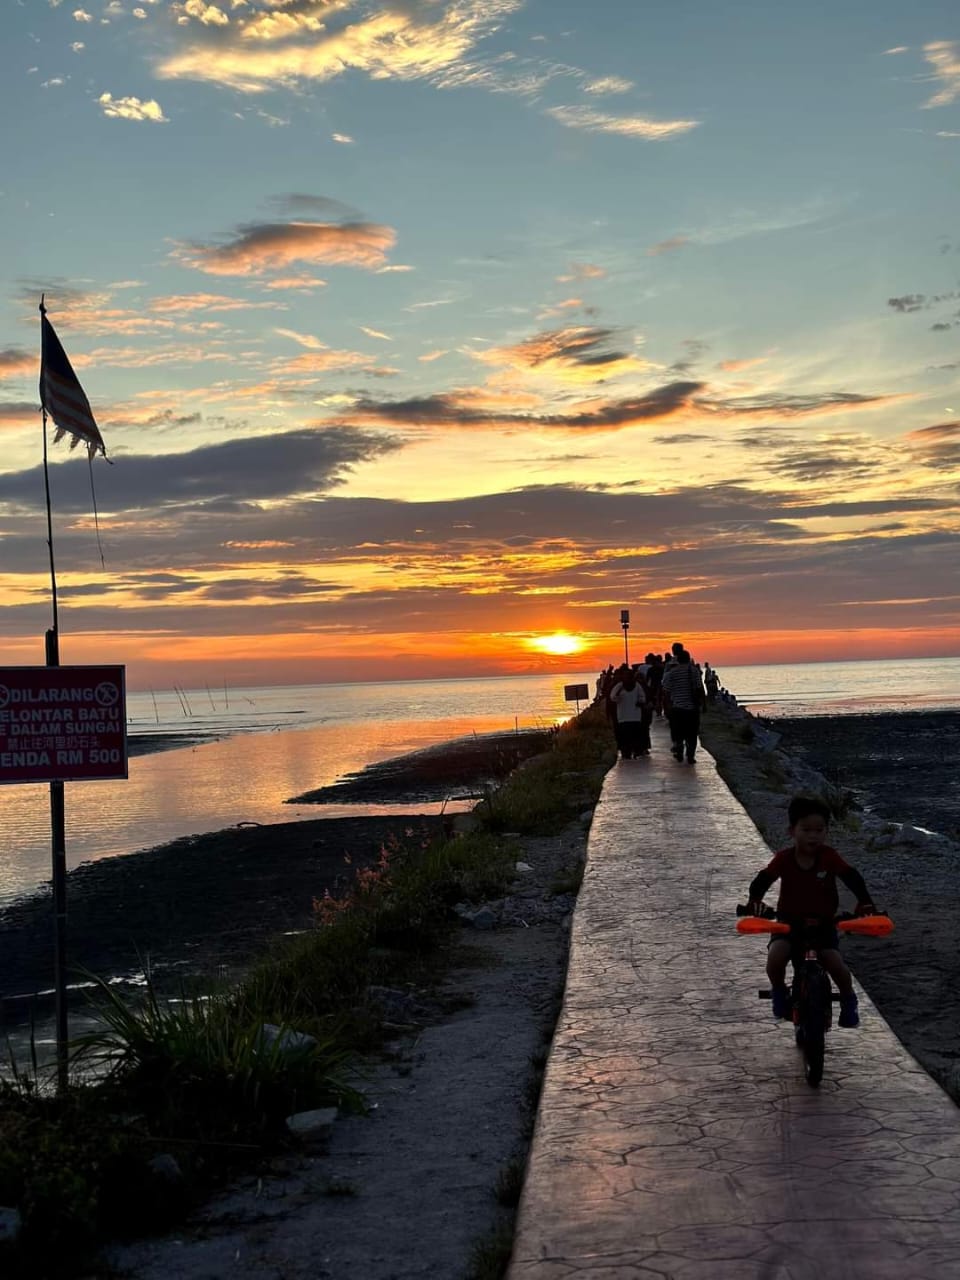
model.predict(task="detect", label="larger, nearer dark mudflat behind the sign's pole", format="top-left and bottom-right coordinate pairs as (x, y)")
top-left (0, 814), bottom-right (438, 1029)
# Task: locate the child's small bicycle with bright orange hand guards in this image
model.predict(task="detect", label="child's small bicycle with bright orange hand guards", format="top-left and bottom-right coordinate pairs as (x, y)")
top-left (737, 905), bottom-right (893, 1088)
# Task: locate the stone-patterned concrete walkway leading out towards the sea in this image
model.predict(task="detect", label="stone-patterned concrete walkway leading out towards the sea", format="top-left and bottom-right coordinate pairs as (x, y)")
top-left (509, 724), bottom-right (960, 1280)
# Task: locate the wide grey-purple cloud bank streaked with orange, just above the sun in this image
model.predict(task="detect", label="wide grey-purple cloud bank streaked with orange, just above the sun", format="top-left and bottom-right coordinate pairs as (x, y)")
top-left (3, 468), bottom-right (960, 650)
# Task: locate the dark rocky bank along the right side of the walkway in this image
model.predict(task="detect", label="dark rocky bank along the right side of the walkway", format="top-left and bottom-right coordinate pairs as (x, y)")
top-left (700, 704), bottom-right (960, 1100)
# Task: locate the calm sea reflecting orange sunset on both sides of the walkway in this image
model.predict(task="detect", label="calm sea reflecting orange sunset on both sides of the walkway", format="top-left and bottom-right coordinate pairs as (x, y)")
top-left (0, 658), bottom-right (960, 904)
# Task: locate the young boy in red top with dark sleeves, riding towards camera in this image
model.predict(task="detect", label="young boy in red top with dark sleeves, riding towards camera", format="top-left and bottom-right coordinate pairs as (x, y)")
top-left (748, 796), bottom-right (876, 1027)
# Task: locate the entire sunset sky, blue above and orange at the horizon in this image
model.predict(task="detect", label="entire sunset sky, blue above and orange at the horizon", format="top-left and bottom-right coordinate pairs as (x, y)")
top-left (0, 0), bottom-right (960, 689)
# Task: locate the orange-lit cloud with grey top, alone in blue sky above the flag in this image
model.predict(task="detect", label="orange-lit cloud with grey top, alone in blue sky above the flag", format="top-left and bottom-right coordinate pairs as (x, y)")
top-left (174, 221), bottom-right (397, 275)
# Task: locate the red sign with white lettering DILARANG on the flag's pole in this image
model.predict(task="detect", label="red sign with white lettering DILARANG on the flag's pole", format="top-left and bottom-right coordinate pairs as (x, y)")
top-left (0, 667), bottom-right (127, 783)
